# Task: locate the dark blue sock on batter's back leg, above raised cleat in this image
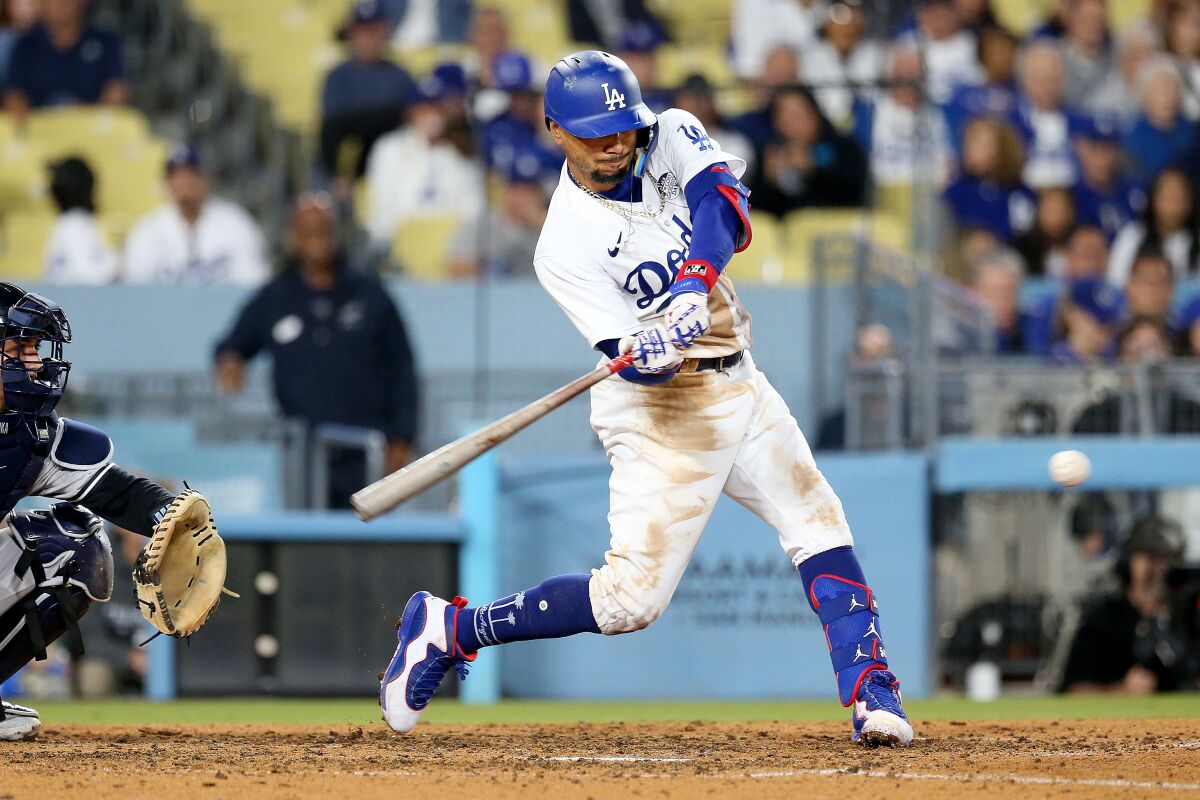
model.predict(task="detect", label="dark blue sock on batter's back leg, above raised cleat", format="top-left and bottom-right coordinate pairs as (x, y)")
top-left (455, 573), bottom-right (600, 652)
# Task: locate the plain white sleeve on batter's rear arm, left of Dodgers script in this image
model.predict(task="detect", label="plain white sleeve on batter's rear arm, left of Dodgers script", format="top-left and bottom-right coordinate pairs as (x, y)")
top-left (533, 255), bottom-right (646, 348)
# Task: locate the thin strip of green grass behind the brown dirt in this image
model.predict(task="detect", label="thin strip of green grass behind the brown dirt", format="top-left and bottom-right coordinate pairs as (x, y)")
top-left (23, 694), bottom-right (1200, 726)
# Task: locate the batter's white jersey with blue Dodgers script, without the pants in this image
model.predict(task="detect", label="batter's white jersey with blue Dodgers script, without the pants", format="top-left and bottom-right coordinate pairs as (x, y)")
top-left (534, 107), bottom-right (751, 357)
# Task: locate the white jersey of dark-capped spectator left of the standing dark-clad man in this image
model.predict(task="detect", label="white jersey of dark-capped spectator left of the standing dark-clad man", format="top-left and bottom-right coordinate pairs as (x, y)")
top-left (121, 198), bottom-right (270, 285)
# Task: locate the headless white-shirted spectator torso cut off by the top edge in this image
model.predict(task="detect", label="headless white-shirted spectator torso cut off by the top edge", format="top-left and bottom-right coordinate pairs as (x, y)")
top-left (730, 0), bottom-right (829, 80)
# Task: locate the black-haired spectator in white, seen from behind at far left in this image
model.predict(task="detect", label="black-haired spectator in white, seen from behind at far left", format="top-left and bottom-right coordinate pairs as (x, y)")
top-left (42, 156), bottom-right (118, 283)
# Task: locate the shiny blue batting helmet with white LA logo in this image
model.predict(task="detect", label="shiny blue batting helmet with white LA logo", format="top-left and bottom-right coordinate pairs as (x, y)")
top-left (545, 50), bottom-right (658, 139)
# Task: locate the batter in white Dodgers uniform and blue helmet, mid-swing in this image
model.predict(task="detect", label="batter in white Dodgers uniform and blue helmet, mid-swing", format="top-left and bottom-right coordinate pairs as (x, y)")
top-left (379, 52), bottom-right (912, 746)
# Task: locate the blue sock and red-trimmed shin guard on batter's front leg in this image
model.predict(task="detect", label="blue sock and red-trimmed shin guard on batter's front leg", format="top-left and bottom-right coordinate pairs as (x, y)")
top-left (800, 546), bottom-right (888, 705)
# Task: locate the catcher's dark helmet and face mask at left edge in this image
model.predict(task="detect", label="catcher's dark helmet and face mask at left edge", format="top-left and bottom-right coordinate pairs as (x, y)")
top-left (0, 283), bottom-right (71, 416)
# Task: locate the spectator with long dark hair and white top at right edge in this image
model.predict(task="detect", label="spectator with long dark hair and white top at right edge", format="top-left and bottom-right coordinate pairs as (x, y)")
top-left (1109, 169), bottom-right (1198, 285)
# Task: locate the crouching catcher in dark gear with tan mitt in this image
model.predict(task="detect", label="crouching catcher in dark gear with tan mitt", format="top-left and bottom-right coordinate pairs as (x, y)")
top-left (0, 283), bottom-right (226, 741)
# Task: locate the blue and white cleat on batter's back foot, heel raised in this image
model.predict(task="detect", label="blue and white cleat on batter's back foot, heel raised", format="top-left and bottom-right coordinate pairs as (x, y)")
top-left (379, 591), bottom-right (479, 733)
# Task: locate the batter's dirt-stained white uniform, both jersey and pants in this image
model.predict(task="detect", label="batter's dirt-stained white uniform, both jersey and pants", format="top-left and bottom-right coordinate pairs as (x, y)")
top-left (534, 109), bottom-right (853, 633)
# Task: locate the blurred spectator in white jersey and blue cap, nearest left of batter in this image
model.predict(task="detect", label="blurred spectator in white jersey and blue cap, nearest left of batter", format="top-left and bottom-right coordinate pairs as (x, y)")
top-left (366, 79), bottom-right (486, 248)
